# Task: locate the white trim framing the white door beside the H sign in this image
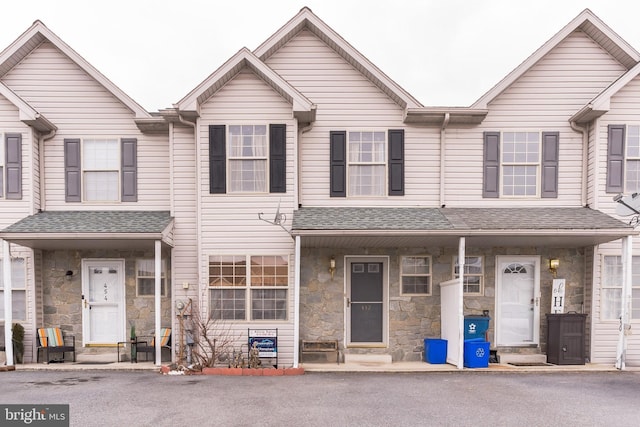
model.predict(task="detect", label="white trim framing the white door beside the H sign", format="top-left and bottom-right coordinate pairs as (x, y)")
top-left (495, 255), bottom-right (540, 347)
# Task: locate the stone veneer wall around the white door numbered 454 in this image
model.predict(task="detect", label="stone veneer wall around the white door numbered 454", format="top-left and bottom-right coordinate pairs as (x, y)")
top-left (42, 250), bottom-right (172, 353)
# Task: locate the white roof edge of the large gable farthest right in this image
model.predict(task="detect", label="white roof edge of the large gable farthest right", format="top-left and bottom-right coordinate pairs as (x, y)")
top-left (472, 9), bottom-right (640, 108)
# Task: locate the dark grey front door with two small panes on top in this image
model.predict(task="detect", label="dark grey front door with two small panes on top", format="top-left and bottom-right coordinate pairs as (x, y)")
top-left (347, 260), bottom-right (386, 346)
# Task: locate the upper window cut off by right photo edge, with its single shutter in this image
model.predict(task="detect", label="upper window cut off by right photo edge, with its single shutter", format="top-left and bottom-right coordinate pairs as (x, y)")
top-left (607, 125), bottom-right (640, 193)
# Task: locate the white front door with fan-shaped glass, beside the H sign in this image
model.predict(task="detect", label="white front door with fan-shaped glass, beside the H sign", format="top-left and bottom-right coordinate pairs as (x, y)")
top-left (496, 256), bottom-right (540, 346)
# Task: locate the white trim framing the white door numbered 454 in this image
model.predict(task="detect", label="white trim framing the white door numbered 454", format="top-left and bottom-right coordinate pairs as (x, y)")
top-left (82, 258), bottom-right (127, 346)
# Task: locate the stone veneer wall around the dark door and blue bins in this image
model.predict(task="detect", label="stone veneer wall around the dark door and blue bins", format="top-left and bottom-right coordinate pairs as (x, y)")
top-left (300, 248), bottom-right (585, 361)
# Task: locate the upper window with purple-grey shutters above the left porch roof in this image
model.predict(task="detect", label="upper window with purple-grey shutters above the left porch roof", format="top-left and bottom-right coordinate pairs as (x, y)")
top-left (64, 138), bottom-right (138, 202)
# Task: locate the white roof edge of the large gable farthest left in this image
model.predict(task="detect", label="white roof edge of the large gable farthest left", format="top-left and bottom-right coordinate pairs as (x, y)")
top-left (0, 21), bottom-right (159, 130)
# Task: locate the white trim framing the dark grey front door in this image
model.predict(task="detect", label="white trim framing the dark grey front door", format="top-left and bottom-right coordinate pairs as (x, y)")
top-left (344, 255), bottom-right (389, 348)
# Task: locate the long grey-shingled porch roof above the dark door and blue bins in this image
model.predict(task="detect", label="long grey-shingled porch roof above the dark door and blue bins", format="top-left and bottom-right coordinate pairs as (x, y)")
top-left (291, 207), bottom-right (638, 247)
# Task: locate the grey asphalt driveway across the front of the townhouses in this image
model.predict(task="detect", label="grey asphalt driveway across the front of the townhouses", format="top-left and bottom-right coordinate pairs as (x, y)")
top-left (0, 371), bottom-right (640, 427)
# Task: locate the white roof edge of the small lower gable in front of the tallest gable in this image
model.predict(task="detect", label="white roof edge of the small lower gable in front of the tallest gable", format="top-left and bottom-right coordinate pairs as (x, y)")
top-left (174, 48), bottom-right (316, 123)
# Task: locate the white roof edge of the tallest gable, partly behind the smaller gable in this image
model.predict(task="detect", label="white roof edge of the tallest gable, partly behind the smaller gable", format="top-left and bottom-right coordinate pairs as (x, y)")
top-left (254, 7), bottom-right (422, 108)
